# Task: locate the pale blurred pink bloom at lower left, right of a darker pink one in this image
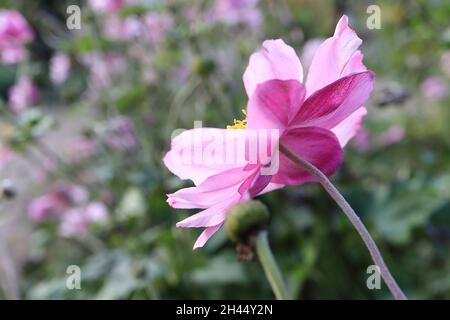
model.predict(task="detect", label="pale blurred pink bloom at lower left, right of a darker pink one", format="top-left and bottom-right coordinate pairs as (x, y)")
top-left (59, 202), bottom-right (108, 238)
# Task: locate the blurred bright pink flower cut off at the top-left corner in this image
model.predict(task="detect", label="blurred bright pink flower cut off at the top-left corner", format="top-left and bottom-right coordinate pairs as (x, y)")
top-left (0, 10), bottom-right (33, 63)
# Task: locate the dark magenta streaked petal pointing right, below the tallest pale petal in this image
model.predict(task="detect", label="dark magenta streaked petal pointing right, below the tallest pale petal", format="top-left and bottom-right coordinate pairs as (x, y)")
top-left (290, 71), bottom-right (375, 129)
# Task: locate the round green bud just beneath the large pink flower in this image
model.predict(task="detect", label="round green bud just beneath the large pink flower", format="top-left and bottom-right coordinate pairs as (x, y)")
top-left (225, 200), bottom-right (270, 242)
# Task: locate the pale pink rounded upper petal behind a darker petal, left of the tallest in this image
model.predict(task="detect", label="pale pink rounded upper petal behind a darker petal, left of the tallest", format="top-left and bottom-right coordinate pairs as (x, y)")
top-left (243, 39), bottom-right (303, 98)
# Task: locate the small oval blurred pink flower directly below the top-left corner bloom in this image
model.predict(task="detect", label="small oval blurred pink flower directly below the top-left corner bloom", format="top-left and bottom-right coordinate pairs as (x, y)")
top-left (8, 77), bottom-right (39, 112)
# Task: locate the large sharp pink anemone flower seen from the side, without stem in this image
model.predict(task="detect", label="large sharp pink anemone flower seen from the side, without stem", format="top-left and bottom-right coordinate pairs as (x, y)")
top-left (164, 16), bottom-right (374, 249)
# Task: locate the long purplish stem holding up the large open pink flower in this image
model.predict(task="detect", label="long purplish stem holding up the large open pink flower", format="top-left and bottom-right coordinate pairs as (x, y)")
top-left (280, 144), bottom-right (407, 300)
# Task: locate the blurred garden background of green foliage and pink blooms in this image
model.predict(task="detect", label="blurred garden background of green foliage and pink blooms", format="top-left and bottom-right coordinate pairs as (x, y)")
top-left (0, 0), bottom-right (450, 299)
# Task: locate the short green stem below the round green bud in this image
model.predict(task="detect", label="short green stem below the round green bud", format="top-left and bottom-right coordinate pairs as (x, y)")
top-left (256, 231), bottom-right (290, 300)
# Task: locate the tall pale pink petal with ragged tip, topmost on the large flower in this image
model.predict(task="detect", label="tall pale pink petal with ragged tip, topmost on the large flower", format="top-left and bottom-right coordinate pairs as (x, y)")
top-left (306, 15), bottom-right (366, 97)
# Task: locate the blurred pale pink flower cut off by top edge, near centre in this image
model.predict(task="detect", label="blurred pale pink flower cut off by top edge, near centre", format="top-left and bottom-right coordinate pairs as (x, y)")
top-left (209, 0), bottom-right (262, 28)
